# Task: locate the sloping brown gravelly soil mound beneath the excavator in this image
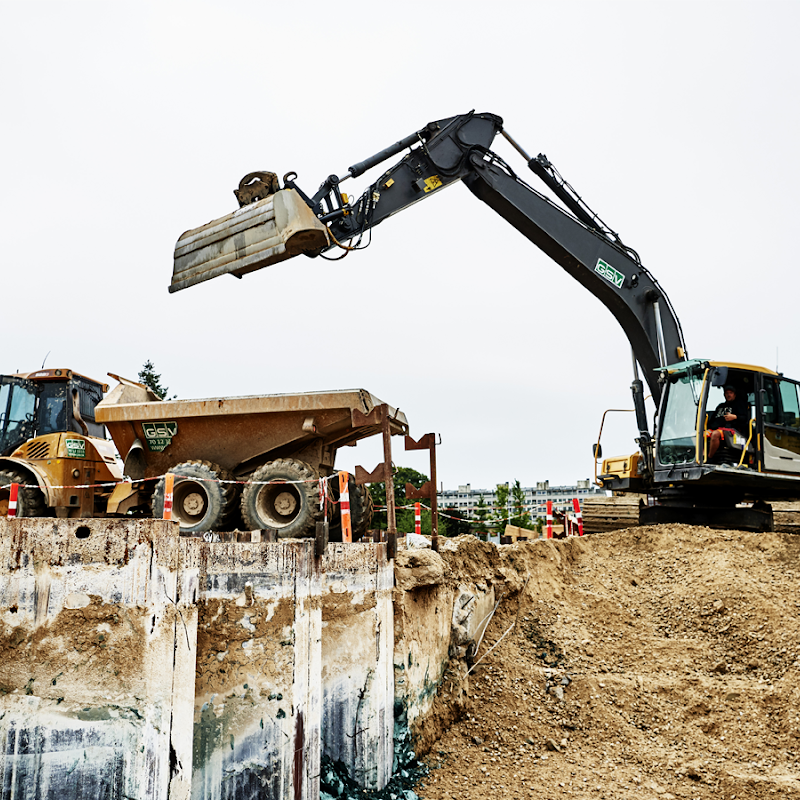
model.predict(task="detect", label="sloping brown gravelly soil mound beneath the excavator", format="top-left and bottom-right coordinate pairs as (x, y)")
top-left (415, 525), bottom-right (800, 800)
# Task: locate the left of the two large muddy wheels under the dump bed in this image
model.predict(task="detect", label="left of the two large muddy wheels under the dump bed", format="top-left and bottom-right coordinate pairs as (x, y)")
top-left (151, 461), bottom-right (236, 533)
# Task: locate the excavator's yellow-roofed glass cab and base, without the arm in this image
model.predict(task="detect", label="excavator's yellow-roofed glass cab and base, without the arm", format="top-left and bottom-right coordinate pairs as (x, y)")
top-left (598, 360), bottom-right (800, 530)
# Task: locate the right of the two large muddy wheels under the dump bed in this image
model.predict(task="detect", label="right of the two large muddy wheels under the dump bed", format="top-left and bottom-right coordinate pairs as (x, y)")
top-left (242, 458), bottom-right (322, 539)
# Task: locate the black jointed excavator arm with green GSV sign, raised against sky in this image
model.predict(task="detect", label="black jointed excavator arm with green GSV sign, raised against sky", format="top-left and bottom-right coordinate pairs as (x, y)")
top-left (171, 112), bottom-right (687, 404)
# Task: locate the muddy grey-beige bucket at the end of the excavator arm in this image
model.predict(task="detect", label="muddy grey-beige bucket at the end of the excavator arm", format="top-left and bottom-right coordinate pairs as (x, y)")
top-left (169, 189), bottom-right (330, 292)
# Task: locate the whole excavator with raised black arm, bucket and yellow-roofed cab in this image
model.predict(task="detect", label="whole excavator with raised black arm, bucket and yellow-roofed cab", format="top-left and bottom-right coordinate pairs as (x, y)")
top-left (169, 111), bottom-right (800, 531)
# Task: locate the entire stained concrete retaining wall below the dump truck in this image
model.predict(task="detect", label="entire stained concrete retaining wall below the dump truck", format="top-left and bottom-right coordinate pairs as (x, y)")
top-left (0, 519), bottom-right (472, 800)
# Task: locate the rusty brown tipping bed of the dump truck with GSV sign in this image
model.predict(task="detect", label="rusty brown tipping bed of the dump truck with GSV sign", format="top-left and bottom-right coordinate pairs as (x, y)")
top-left (95, 385), bottom-right (408, 478)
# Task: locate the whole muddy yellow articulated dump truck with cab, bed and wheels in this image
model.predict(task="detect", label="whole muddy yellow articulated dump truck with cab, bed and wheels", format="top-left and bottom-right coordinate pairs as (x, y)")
top-left (0, 370), bottom-right (408, 540)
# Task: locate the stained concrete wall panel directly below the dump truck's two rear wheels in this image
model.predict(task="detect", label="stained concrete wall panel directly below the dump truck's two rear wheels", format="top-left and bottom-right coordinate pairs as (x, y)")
top-left (181, 539), bottom-right (321, 800)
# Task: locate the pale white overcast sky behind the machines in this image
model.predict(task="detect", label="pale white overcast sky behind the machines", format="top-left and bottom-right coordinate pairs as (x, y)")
top-left (0, 0), bottom-right (800, 488)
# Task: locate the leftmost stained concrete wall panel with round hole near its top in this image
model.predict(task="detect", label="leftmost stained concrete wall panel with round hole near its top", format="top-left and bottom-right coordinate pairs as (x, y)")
top-left (0, 519), bottom-right (197, 800)
